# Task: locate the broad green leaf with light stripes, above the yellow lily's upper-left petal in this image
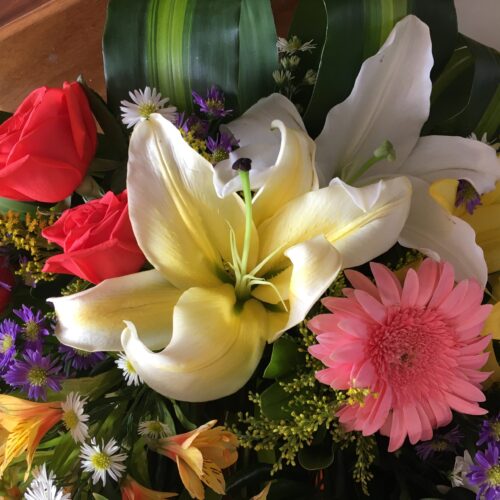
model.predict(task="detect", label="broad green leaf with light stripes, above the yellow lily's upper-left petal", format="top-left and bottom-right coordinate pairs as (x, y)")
top-left (103, 0), bottom-right (277, 114)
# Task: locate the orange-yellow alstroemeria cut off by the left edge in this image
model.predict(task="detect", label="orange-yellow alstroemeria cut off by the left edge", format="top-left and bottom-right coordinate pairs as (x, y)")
top-left (0, 395), bottom-right (63, 480)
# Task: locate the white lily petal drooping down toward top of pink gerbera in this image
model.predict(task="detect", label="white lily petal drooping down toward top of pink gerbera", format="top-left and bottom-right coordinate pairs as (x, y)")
top-left (399, 178), bottom-right (488, 286)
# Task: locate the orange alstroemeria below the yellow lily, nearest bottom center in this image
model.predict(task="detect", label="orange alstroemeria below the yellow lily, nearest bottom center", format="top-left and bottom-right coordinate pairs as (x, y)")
top-left (150, 420), bottom-right (238, 500)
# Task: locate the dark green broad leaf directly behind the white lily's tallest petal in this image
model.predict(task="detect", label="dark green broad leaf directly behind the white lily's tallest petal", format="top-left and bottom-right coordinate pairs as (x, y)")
top-left (290, 0), bottom-right (457, 136)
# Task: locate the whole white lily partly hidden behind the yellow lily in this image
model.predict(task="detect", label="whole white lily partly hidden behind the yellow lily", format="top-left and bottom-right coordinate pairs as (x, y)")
top-left (215, 16), bottom-right (500, 284)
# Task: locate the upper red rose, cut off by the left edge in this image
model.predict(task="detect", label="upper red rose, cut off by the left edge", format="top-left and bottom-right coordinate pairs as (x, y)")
top-left (0, 82), bottom-right (97, 203)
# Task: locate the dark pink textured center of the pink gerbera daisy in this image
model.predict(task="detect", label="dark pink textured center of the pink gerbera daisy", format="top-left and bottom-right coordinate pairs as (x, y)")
top-left (367, 306), bottom-right (453, 389)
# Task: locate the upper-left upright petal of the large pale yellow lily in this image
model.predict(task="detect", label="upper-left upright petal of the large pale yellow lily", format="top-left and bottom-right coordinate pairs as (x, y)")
top-left (127, 114), bottom-right (258, 289)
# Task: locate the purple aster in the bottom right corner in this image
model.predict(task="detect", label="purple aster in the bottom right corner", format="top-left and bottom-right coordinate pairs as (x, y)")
top-left (467, 443), bottom-right (500, 500)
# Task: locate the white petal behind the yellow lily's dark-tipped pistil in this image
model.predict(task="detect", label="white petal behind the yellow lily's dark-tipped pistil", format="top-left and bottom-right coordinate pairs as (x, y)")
top-left (214, 94), bottom-right (306, 196)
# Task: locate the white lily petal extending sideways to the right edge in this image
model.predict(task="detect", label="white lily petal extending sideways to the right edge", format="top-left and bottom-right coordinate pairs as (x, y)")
top-left (394, 135), bottom-right (500, 193)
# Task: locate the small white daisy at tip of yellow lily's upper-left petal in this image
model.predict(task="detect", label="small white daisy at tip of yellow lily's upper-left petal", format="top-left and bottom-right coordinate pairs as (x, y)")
top-left (120, 87), bottom-right (177, 128)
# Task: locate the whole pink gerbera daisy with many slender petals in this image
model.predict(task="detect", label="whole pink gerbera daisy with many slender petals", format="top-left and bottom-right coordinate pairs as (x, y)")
top-left (309, 259), bottom-right (491, 451)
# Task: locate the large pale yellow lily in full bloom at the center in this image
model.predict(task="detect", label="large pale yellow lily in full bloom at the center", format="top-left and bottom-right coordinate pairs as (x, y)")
top-left (51, 114), bottom-right (411, 402)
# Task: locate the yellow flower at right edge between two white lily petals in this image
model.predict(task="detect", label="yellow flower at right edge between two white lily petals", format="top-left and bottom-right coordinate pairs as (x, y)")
top-left (429, 180), bottom-right (500, 273)
